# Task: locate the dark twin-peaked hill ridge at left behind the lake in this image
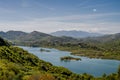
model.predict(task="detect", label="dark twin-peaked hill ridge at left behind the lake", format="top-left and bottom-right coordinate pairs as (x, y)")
top-left (0, 31), bottom-right (77, 46)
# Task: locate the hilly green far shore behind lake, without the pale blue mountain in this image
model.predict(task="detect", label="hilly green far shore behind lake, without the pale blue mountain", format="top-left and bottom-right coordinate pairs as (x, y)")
top-left (1, 31), bottom-right (120, 60)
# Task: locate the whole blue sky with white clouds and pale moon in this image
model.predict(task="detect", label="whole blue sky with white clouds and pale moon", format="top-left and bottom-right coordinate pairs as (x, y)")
top-left (0, 0), bottom-right (120, 34)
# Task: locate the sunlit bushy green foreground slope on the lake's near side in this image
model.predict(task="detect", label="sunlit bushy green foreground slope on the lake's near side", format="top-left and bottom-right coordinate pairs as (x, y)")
top-left (0, 38), bottom-right (120, 80)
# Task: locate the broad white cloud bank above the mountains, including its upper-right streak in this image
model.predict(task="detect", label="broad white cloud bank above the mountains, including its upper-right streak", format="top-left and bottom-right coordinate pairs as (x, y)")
top-left (0, 13), bottom-right (120, 33)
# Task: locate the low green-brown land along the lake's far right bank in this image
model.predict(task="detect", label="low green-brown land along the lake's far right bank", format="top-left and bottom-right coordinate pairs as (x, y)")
top-left (43, 40), bottom-right (120, 60)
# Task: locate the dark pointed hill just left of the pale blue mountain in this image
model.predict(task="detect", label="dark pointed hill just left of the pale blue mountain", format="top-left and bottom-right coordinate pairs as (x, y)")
top-left (15, 31), bottom-right (77, 46)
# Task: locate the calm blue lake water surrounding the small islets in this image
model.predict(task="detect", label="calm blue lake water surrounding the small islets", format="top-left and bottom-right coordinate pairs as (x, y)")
top-left (20, 46), bottom-right (120, 76)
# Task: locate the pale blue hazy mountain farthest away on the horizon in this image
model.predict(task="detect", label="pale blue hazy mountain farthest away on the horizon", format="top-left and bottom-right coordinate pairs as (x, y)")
top-left (51, 30), bottom-right (102, 38)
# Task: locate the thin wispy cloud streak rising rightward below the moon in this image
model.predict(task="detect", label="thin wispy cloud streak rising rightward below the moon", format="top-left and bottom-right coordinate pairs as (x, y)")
top-left (36, 13), bottom-right (120, 21)
